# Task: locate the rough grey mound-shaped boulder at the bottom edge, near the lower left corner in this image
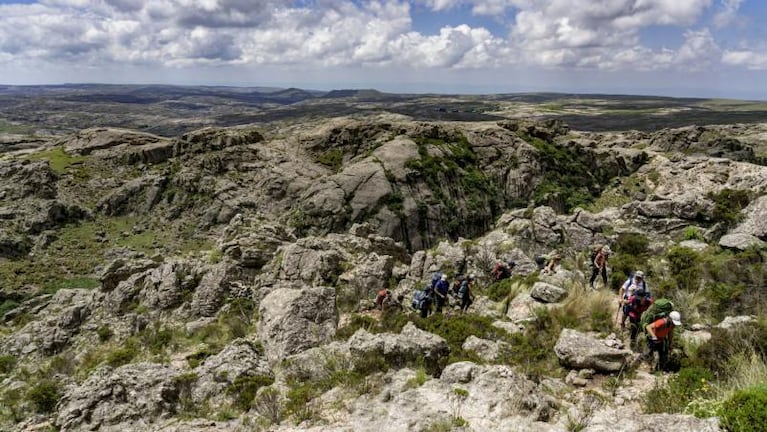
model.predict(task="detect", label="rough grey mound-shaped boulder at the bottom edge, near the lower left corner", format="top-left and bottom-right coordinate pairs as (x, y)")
top-left (55, 363), bottom-right (184, 431)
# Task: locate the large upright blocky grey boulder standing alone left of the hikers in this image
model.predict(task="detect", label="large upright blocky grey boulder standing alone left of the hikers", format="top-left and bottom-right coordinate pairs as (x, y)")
top-left (258, 287), bottom-right (338, 363)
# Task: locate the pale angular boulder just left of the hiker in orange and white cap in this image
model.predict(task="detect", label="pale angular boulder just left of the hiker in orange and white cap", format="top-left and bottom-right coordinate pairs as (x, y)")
top-left (554, 329), bottom-right (633, 373)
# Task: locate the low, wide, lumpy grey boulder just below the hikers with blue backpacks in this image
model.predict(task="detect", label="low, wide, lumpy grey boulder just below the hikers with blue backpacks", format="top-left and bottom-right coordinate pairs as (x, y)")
top-left (349, 322), bottom-right (450, 373)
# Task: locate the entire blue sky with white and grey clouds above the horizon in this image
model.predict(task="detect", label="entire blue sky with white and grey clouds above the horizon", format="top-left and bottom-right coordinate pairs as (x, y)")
top-left (0, 0), bottom-right (767, 100)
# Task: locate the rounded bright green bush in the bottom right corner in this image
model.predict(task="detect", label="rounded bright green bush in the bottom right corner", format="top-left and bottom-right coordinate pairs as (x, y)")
top-left (720, 385), bottom-right (767, 432)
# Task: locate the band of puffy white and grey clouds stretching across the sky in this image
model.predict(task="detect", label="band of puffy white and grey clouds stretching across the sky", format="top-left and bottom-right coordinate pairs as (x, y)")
top-left (0, 0), bottom-right (767, 87)
